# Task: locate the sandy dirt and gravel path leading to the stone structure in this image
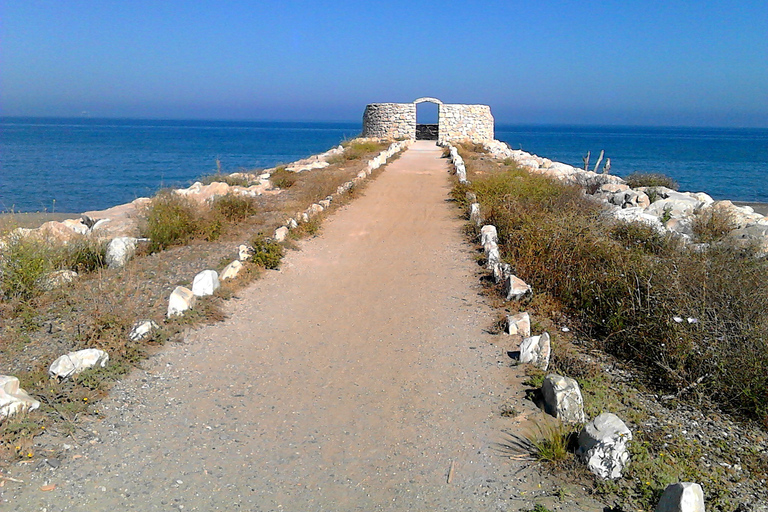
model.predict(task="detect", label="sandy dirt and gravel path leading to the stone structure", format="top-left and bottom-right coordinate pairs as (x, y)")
top-left (0, 142), bottom-right (602, 512)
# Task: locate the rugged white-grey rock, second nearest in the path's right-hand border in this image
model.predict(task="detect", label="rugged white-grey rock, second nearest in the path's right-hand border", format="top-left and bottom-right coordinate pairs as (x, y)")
top-left (576, 412), bottom-right (632, 480)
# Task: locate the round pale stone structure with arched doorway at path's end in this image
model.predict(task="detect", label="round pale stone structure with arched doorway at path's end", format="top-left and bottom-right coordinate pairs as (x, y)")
top-left (363, 98), bottom-right (494, 144)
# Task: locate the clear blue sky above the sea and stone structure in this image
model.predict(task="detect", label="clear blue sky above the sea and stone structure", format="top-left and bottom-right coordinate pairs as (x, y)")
top-left (0, 0), bottom-right (768, 127)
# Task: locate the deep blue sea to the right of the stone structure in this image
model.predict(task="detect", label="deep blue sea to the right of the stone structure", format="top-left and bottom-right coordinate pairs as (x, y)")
top-left (496, 126), bottom-right (768, 202)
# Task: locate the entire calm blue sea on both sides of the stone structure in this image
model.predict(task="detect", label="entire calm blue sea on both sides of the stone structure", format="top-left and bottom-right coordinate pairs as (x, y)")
top-left (0, 117), bottom-right (768, 213)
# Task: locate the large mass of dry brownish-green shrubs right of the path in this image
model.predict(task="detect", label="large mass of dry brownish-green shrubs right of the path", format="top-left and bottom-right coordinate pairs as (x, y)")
top-left (464, 163), bottom-right (768, 421)
